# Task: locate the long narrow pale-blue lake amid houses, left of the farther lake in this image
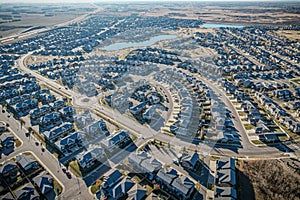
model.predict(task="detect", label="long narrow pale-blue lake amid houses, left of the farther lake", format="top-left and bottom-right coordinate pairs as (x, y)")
top-left (103, 35), bottom-right (176, 51)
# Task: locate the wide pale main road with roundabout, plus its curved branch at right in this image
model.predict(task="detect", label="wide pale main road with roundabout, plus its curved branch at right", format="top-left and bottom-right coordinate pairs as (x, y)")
top-left (18, 52), bottom-right (297, 157)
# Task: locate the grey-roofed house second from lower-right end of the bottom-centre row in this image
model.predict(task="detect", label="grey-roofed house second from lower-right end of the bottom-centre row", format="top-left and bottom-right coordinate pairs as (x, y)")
top-left (155, 168), bottom-right (178, 191)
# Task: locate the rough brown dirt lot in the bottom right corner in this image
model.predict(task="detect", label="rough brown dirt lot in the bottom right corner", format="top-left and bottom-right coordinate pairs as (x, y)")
top-left (237, 159), bottom-right (300, 200)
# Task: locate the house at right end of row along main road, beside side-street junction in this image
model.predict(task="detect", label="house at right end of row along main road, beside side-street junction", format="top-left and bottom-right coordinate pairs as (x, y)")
top-left (100, 130), bottom-right (132, 153)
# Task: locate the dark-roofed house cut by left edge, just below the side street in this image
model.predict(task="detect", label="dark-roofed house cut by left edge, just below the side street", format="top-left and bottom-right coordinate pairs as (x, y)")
top-left (0, 160), bottom-right (18, 182)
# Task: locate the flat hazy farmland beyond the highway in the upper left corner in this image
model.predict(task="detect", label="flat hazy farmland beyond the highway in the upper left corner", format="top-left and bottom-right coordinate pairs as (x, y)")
top-left (0, 4), bottom-right (94, 38)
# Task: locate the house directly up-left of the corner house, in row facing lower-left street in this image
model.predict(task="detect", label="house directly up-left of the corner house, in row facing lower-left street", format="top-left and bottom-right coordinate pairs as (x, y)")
top-left (55, 131), bottom-right (84, 153)
